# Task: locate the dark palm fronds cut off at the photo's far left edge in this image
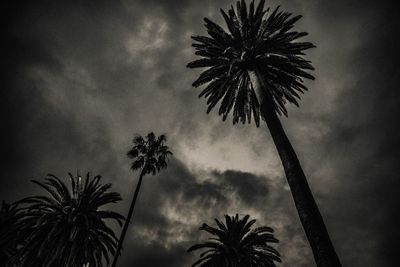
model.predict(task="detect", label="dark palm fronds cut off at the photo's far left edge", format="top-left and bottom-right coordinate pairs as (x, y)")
top-left (0, 200), bottom-right (21, 266)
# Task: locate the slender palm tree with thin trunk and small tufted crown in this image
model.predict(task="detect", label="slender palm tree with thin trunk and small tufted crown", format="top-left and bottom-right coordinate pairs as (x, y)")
top-left (112, 132), bottom-right (172, 267)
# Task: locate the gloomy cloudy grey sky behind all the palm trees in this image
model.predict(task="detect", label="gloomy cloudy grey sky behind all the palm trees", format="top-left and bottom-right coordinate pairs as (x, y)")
top-left (0, 0), bottom-right (400, 267)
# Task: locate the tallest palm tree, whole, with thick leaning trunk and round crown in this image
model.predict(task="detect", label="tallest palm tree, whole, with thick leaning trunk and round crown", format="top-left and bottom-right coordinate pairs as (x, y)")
top-left (188, 0), bottom-right (341, 267)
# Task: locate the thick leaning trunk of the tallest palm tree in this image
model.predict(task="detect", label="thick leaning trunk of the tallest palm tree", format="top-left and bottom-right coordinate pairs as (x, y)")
top-left (249, 71), bottom-right (341, 267)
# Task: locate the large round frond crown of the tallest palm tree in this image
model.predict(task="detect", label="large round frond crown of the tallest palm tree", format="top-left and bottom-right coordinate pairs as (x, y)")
top-left (188, 0), bottom-right (315, 126)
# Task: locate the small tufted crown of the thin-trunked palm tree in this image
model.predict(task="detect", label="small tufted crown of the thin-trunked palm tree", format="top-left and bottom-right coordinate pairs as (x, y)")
top-left (127, 132), bottom-right (172, 175)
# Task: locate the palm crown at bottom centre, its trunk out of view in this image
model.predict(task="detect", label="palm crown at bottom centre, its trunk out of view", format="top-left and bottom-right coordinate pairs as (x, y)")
top-left (188, 214), bottom-right (281, 267)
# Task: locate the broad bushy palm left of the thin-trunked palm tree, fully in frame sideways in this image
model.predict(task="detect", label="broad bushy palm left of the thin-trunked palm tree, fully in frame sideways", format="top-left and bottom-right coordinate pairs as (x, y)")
top-left (18, 173), bottom-right (124, 267)
